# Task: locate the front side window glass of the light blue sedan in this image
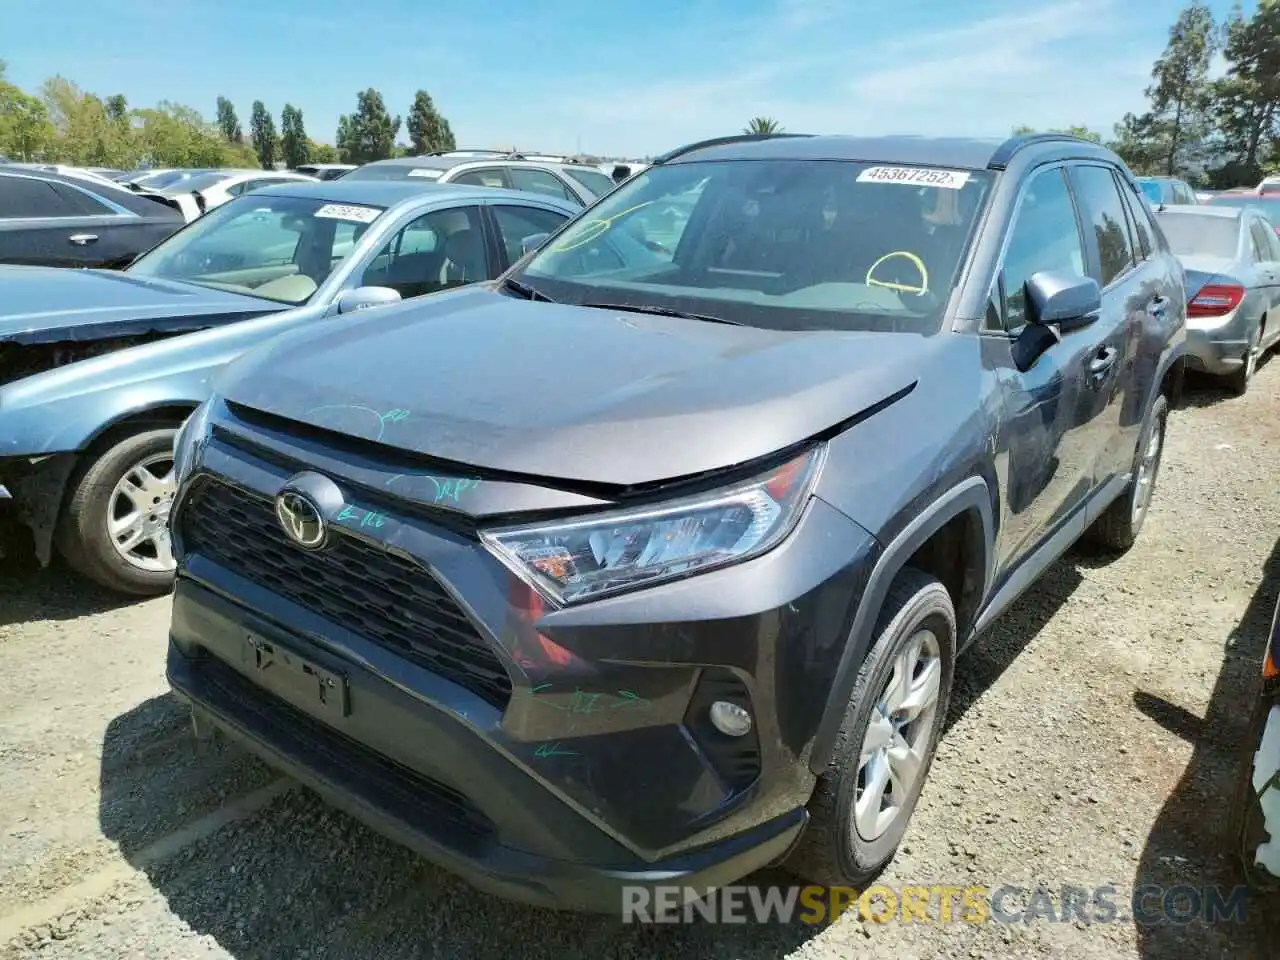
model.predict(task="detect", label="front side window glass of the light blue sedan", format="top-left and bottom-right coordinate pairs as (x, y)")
top-left (360, 207), bottom-right (489, 300)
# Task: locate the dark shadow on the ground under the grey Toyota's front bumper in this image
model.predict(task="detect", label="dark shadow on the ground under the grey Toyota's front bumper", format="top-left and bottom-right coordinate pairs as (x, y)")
top-left (99, 695), bottom-right (822, 960)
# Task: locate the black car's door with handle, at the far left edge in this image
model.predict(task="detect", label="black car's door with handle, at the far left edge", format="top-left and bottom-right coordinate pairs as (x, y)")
top-left (0, 174), bottom-right (136, 266)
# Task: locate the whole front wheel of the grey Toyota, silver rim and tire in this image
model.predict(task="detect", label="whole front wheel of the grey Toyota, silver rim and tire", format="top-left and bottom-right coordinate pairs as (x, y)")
top-left (786, 567), bottom-right (956, 887)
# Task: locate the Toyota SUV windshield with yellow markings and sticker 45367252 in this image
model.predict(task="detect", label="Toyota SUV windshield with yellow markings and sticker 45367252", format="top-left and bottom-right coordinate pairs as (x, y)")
top-left (517, 160), bottom-right (992, 333)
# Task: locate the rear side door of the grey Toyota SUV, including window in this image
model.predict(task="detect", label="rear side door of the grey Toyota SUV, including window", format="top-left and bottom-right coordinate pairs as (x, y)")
top-left (1069, 163), bottom-right (1174, 488)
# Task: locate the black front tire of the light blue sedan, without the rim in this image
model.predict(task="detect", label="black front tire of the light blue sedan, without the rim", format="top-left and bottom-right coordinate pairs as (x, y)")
top-left (54, 428), bottom-right (177, 596)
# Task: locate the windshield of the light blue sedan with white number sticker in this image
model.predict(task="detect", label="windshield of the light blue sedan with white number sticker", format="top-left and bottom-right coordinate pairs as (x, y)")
top-left (127, 193), bottom-right (384, 305)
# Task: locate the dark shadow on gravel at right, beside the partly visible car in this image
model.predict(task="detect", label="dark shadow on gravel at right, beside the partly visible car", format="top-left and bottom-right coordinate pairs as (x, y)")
top-left (1134, 541), bottom-right (1280, 960)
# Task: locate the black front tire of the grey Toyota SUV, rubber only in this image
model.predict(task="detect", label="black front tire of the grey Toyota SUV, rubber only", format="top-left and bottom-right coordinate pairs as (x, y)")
top-left (785, 567), bottom-right (956, 887)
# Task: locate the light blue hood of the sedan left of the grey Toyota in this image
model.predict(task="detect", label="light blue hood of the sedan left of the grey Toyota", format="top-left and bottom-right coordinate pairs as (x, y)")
top-left (0, 266), bottom-right (288, 343)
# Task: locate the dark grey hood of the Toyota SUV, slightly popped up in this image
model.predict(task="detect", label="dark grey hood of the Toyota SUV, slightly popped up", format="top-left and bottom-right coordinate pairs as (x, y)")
top-left (216, 288), bottom-right (921, 486)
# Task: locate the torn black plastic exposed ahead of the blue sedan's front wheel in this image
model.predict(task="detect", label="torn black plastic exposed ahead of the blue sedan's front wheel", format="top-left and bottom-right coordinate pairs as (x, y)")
top-left (0, 453), bottom-right (77, 567)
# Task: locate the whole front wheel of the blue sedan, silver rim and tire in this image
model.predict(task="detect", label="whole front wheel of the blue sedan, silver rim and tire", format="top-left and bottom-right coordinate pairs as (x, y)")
top-left (55, 428), bottom-right (177, 596)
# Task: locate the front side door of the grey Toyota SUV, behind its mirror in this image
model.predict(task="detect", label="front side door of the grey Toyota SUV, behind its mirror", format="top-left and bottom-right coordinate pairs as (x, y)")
top-left (988, 164), bottom-right (1097, 576)
